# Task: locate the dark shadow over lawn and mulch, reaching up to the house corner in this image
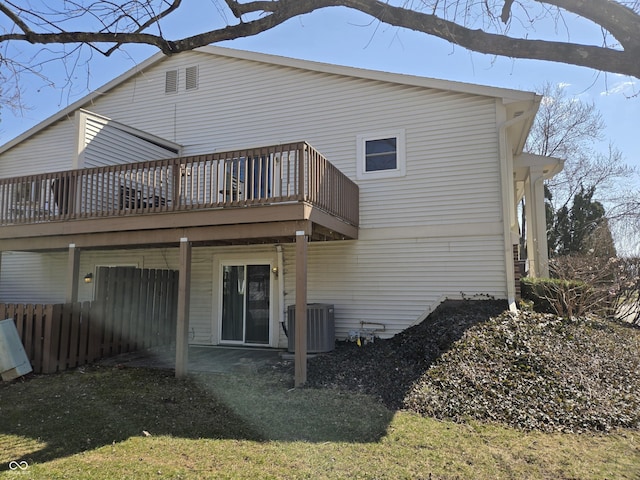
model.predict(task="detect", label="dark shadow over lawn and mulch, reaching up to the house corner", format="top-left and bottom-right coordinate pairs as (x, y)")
top-left (0, 301), bottom-right (504, 471)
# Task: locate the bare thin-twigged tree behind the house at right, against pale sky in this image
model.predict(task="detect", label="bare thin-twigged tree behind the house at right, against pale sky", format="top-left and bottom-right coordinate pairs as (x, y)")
top-left (523, 84), bottom-right (640, 254)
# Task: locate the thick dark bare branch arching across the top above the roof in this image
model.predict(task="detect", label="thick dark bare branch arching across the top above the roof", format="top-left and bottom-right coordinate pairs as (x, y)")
top-left (0, 0), bottom-right (640, 78)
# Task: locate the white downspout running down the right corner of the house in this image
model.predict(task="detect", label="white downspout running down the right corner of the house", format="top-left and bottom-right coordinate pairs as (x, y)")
top-left (498, 100), bottom-right (538, 312)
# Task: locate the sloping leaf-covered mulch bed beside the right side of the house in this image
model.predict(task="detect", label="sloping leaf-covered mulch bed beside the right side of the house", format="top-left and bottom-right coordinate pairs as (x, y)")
top-left (276, 300), bottom-right (640, 433)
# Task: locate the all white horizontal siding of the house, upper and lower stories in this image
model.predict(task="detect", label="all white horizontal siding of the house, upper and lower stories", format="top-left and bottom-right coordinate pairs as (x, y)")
top-left (0, 52), bottom-right (512, 346)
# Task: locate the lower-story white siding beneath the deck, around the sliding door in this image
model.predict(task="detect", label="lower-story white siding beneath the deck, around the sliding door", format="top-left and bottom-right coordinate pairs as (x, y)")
top-left (0, 235), bottom-right (505, 347)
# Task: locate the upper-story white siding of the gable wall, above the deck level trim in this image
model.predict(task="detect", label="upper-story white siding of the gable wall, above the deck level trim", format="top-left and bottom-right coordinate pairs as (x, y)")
top-left (84, 52), bottom-right (501, 228)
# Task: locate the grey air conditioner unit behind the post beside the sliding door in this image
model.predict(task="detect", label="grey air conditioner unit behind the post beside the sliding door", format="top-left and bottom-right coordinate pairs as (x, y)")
top-left (287, 303), bottom-right (336, 353)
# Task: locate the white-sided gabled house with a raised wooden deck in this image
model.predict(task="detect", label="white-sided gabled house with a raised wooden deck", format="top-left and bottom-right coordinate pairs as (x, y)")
top-left (0, 47), bottom-right (562, 382)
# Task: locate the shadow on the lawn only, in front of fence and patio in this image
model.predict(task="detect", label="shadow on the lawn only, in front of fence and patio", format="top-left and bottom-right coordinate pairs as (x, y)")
top-left (0, 366), bottom-right (392, 471)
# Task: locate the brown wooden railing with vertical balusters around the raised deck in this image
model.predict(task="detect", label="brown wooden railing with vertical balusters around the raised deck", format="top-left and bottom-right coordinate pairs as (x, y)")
top-left (0, 142), bottom-right (359, 226)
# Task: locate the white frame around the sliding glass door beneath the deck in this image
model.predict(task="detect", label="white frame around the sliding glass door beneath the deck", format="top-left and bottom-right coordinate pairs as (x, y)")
top-left (211, 252), bottom-right (282, 348)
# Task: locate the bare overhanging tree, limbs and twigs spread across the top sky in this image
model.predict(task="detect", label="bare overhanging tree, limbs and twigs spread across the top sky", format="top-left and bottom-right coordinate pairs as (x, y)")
top-left (0, 0), bottom-right (640, 78)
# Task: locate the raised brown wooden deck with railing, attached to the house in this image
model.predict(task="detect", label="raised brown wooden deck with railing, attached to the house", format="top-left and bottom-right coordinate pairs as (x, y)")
top-left (0, 142), bottom-right (359, 251)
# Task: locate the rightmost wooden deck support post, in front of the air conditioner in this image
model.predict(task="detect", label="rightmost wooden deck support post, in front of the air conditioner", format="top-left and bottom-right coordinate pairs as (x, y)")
top-left (294, 231), bottom-right (307, 387)
